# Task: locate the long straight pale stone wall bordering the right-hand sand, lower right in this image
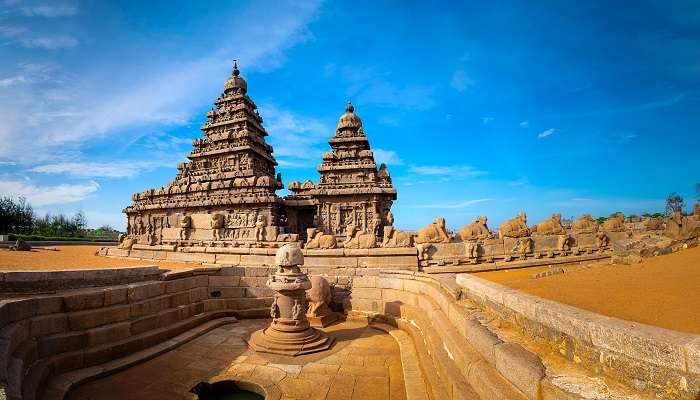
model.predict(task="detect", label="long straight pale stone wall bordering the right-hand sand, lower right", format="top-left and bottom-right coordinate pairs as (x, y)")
top-left (457, 274), bottom-right (700, 399)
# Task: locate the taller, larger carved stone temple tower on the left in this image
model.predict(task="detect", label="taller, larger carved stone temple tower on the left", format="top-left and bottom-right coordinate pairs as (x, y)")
top-left (124, 61), bottom-right (283, 245)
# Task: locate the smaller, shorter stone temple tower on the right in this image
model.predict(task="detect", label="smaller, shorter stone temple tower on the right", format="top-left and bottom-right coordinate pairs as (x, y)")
top-left (286, 103), bottom-right (396, 237)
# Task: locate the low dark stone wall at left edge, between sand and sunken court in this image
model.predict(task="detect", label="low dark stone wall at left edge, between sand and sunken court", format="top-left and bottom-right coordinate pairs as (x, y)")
top-left (0, 265), bottom-right (165, 293)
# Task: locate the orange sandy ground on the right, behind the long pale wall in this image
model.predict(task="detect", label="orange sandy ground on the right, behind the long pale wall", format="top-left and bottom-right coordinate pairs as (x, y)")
top-left (475, 247), bottom-right (700, 333)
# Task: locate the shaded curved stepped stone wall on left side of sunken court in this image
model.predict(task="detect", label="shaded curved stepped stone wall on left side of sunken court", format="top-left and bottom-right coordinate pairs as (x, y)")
top-left (0, 267), bottom-right (273, 400)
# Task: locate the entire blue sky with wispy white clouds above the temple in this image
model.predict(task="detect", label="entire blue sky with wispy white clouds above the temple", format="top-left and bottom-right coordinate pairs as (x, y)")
top-left (0, 0), bottom-right (700, 229)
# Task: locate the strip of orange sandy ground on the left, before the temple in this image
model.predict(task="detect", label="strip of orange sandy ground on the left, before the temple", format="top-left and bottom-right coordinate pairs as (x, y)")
top-left (0, 245), bottom-right (201, 271)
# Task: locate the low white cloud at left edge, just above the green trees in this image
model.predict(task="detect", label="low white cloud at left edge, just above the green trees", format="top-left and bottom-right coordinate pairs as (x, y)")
top-left (0, 179), bottom-right (100, 207)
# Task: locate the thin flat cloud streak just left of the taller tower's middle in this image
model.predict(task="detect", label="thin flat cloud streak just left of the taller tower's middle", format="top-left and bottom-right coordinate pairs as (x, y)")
top-left (29, 160), bottom-right (176, 178)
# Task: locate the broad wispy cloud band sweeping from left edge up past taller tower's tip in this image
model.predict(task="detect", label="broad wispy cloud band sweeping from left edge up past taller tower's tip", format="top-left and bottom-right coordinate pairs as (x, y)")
top-left (0, 2), bottom-right (319, 164)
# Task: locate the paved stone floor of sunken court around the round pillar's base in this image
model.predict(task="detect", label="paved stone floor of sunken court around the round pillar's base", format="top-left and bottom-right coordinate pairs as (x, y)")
top-left (67, 320), bottom-right (406, 400)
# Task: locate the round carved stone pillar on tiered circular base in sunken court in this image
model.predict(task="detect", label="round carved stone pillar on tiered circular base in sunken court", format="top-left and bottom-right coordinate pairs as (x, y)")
top-left (248, 244), bottom-right (333, 356)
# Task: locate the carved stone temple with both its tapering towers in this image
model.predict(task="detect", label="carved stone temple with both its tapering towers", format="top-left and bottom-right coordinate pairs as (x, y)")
top-left (122, 64), bottom-right (396, 251)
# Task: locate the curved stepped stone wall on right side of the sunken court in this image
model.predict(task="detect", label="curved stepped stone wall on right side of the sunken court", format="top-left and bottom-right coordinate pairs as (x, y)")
top-left (346, 271), bottom-right (548, 400)
